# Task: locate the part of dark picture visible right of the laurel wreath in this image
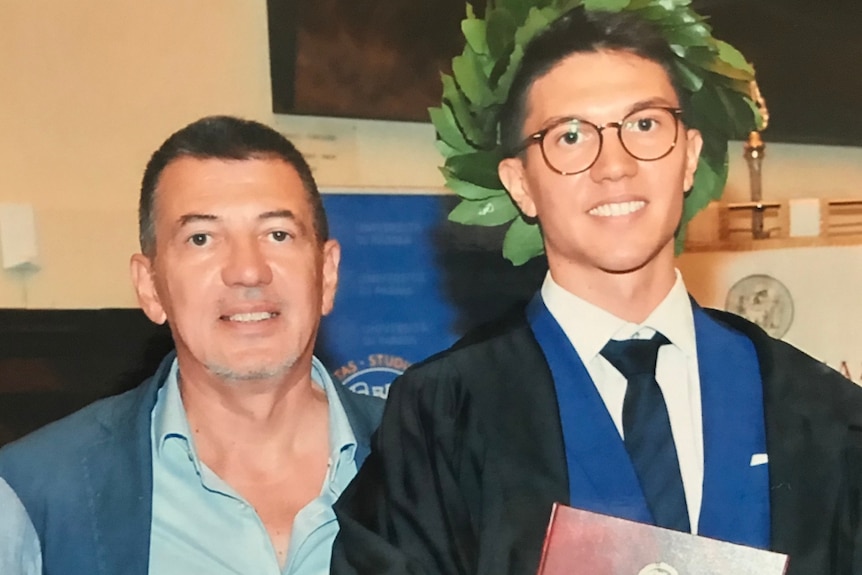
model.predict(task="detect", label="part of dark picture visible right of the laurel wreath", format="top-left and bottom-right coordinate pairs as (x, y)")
top-left (692, 0), bottom-right (862, 146)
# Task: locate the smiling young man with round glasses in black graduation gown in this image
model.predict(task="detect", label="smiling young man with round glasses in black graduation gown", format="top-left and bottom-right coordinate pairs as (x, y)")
top-left (333, 8), bottom-right (862, 575)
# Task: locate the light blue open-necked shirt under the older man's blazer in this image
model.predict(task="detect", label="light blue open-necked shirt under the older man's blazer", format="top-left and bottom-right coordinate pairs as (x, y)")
top-left (150, 358), bottom-right (356, 575)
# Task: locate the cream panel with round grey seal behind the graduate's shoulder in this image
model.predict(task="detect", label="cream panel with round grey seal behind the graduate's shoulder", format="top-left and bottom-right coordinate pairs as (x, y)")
top-left (679, 245), bottom-right (862, 385)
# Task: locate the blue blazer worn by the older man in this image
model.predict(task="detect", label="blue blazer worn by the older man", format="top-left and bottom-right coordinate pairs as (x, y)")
top-left (0, 352), bottom-right (383, 575)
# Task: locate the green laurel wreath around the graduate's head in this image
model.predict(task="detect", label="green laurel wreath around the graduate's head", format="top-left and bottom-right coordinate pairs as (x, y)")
top-left (429, 0), bottom-right (762, 265)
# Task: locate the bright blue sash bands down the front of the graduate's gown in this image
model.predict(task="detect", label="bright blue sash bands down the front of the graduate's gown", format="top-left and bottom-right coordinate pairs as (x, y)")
top-left (527, 294), bottom-right (770, 549)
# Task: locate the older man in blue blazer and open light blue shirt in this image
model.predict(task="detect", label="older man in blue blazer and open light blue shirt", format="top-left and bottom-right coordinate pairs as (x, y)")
top-left (0, 117), bottom-right (382, 575)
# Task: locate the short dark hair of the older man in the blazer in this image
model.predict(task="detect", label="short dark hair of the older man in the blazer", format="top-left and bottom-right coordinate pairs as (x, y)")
top-left (138, 116), bottom-right (329, 256)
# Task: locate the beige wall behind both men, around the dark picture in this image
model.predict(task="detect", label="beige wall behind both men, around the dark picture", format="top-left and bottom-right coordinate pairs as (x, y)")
top-left (0, 0), bottom-right (862, 308)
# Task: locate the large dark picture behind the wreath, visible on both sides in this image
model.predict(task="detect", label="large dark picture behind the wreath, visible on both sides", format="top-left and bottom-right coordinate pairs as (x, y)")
top-left (267, 0), bottom-right (862, 145)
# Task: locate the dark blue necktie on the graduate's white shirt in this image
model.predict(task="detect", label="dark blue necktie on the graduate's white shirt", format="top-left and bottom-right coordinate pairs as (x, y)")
top-left (601, 332), bottom-right (690, 531)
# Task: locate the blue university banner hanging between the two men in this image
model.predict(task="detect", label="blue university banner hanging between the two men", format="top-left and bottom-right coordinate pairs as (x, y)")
top-left (316, 193), bottom-right (544, 397)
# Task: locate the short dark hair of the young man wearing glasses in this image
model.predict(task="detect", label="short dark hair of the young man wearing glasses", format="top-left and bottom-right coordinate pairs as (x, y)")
top-left (498, 5), bottom-right (686, 157)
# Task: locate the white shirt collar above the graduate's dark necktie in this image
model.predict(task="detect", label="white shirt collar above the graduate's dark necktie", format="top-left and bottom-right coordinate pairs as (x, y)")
top-left (542, 270), bottom-right (696, 363)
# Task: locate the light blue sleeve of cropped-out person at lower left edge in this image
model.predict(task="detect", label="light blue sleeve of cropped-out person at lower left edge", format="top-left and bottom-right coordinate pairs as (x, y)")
top-left (0, 479), bottom-right (42, 575)
